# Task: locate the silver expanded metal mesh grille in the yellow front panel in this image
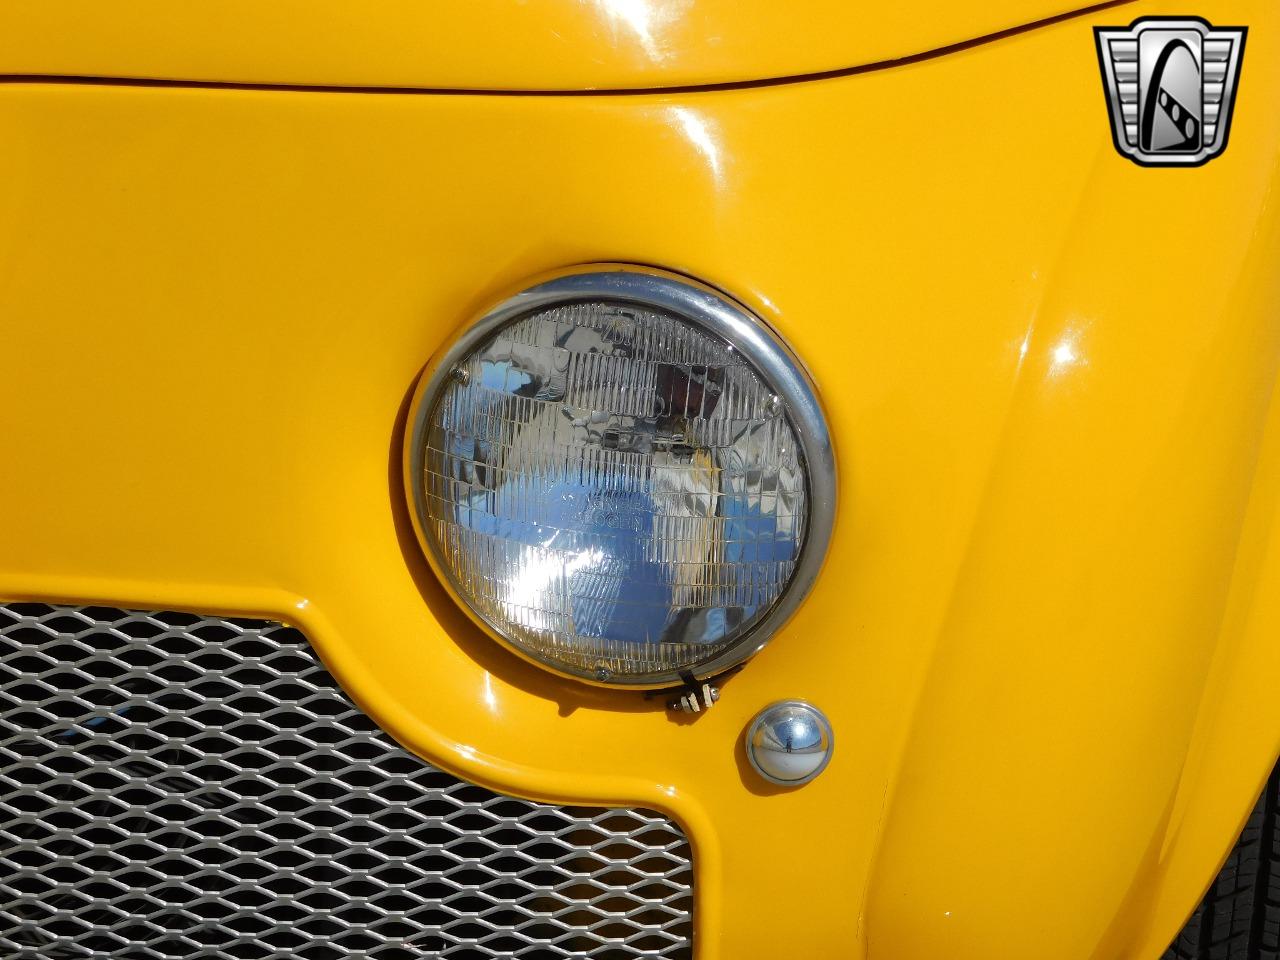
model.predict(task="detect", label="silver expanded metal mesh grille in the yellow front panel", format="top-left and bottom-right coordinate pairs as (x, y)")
top-left (0, 604), bottom-right (692, 960)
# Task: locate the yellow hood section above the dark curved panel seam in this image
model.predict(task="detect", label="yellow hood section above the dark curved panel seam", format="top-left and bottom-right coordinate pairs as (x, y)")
top-left (0, 0), bottom-right (1121, 90)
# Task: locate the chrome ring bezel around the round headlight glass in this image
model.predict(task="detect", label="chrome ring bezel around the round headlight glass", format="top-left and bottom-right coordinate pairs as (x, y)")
top-left (404, 265), bottom-right (836, 690)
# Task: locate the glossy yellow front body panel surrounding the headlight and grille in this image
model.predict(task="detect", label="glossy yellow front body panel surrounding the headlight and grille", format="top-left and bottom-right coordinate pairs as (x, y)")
top-left (0, 0), bottom-right (1280, 960)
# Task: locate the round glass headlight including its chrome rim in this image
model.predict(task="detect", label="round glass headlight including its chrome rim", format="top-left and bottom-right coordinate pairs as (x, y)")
top-left (408, 268), bottom-right (835, 687)
